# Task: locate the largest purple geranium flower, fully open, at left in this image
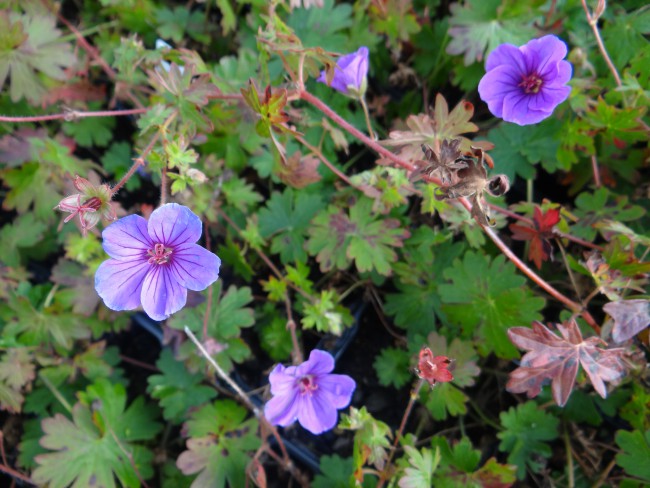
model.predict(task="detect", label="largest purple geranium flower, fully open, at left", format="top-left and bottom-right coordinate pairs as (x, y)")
top-left (95, 203), bottom-right (221, 320)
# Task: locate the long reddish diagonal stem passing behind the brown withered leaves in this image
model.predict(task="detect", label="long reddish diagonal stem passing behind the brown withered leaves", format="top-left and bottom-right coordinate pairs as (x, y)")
top-left (299, 91), bottom-right (600, 332)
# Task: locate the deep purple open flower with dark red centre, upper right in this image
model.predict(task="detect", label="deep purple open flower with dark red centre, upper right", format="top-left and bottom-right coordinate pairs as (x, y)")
top-left (478, 36), bottom-right (572, 125)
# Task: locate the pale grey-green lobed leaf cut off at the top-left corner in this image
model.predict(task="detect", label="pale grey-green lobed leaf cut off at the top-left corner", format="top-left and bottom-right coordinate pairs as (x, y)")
top-left (0, 10), bottom-right (75, 103)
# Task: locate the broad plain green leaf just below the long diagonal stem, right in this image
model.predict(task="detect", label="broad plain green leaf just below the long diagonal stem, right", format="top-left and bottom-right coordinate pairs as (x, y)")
top-left (438, 251), bottom-right (545, 358)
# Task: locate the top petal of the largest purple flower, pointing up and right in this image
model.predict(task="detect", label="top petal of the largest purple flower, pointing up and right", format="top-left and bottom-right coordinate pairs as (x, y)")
top-left (148, 203), bottom-right (203, 247)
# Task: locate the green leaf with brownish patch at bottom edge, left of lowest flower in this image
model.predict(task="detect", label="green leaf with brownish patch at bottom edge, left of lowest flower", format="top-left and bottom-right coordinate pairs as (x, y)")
top-left (176, 400), bottom-right (260, 488)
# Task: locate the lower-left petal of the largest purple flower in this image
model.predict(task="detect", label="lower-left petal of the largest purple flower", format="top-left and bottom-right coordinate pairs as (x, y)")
top-left (95, 258), bottom-right (151, 310)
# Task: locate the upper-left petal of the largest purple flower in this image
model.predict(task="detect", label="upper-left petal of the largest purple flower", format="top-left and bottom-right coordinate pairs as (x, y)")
top-left (102, 215), bottom-right (154, 261)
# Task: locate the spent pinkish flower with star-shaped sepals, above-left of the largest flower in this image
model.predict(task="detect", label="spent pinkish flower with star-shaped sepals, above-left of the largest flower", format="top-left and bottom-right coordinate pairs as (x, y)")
top-left (54, 176), bottom-right (117, 235)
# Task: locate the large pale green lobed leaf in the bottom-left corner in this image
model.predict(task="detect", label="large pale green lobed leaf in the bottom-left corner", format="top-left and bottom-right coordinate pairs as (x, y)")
top-left (32, 380), bottom-right (161, 488)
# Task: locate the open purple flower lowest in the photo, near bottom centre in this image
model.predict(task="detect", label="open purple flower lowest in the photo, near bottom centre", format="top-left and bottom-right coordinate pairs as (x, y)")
top-left (264, 349), bottom-right (357, 434)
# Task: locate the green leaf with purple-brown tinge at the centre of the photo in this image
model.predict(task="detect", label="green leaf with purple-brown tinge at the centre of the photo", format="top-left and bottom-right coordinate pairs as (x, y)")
top-left (307, 198), bottom-right (410, 276)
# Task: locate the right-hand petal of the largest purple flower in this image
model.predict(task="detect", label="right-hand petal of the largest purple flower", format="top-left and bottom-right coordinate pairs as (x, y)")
top-left (169, 244), bottom-right (221, 291)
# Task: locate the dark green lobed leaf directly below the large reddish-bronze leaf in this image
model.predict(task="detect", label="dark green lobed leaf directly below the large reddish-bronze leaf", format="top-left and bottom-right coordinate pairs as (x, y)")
top-left (497, 401), bottom-right (559, 480)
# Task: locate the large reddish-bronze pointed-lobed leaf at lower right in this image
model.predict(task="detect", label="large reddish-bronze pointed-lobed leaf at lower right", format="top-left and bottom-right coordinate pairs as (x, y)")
top-left (506, 320), bottom-right (626, 406)
